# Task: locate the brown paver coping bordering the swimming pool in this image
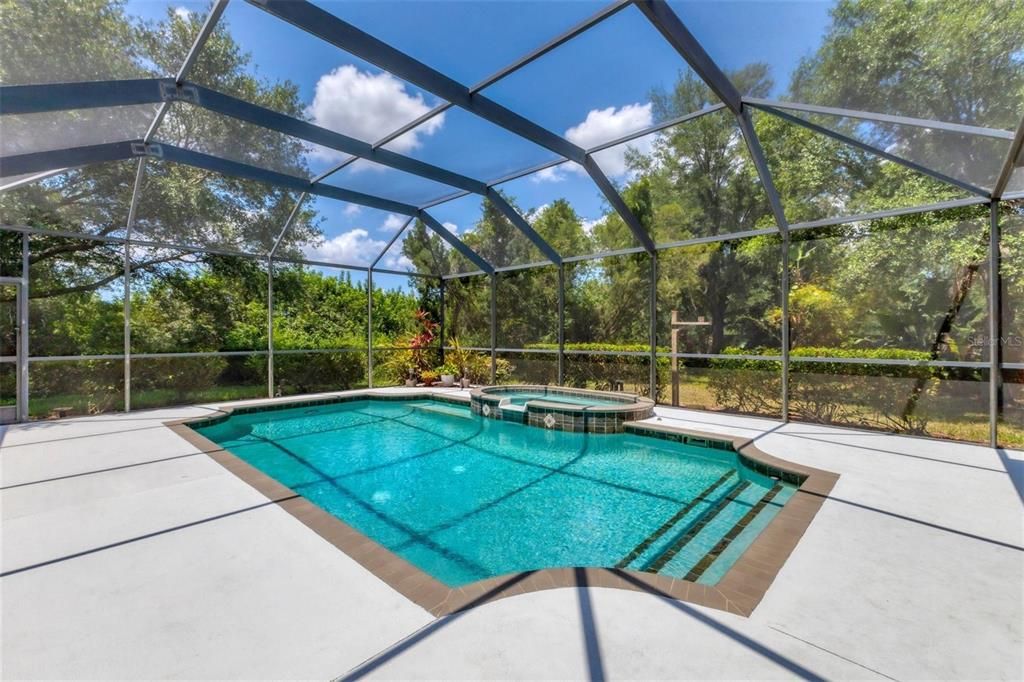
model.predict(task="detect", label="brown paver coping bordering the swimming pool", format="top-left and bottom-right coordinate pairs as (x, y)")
top-left (165, 390), bottom-right (839, 616)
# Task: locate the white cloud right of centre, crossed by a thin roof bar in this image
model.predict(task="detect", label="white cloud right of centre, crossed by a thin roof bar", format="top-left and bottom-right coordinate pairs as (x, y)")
top-left (530, 102), bottom-right (654, 182)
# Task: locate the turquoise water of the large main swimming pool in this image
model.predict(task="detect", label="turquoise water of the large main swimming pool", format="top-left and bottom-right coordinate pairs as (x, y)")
top-left (197, 400), bottom-right (795, 587)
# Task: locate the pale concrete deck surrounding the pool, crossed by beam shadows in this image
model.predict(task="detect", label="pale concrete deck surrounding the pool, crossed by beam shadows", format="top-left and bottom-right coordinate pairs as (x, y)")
top-left (0, 389), bottom-right (1024, 679)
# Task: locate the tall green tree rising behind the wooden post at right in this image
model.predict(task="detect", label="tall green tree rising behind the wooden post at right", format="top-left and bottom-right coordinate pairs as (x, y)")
top-left (618, 65), bottom-right (779, 352)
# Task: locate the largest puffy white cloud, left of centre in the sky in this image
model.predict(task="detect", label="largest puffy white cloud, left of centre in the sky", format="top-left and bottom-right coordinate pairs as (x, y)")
top-left (306, 65), bottom-right (444, 162)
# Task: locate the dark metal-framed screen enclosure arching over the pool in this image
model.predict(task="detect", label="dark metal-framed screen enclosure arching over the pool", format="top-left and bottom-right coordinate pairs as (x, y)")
top-left (0, 0), bottom-right (1024, 447)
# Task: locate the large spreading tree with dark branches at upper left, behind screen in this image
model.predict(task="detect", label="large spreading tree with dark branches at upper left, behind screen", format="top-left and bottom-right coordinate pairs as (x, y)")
top-left (0, 0), bottom-right (318, 305)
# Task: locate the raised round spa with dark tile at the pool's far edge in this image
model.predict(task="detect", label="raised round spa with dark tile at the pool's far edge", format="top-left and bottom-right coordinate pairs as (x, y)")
top-left (470, 384), bottom-right (654, 433)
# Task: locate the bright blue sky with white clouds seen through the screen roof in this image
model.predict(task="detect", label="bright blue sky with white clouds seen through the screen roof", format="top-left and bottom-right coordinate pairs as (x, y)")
top-left (127, 0), bottom-right (830, 286)
